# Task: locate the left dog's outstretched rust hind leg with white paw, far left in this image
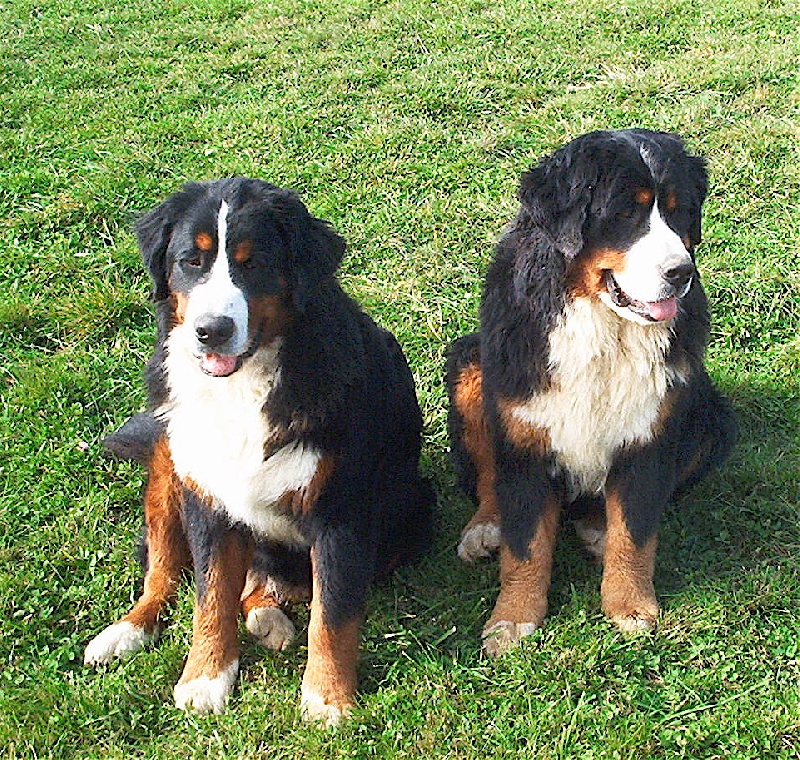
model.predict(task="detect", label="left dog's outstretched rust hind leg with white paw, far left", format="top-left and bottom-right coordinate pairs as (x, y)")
top-left (84, 438), bottom-right (189, 665)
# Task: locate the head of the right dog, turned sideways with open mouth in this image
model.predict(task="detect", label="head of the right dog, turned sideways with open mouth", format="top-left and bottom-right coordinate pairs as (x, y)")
top-left (519, 130), bottom-right (707, 323)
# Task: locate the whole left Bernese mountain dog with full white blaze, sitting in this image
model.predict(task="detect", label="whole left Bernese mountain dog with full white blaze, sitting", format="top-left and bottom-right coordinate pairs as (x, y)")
top-left (85, 178), bottom-right (434, 724)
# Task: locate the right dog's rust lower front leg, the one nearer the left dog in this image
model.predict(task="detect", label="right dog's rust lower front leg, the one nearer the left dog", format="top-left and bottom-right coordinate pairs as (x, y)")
top-left (483, 496), bottom-right (560, 657)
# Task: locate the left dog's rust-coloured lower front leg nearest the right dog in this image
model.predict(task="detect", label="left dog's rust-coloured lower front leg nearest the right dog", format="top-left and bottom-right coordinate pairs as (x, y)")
top-left (301, 550), bottom-right (362, 726)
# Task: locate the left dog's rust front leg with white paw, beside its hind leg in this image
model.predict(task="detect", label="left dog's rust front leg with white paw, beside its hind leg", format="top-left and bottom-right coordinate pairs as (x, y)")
top-left (175, 531), bottom-right (252, 713)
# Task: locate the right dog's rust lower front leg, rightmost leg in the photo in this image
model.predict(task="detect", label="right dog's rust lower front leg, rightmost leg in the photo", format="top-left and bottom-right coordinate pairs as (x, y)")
top-left (600, 494), bottom-right (658, 631)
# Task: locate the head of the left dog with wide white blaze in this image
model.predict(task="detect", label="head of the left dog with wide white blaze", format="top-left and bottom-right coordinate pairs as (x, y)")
top-left (136, 178), bottom-right (345, 376)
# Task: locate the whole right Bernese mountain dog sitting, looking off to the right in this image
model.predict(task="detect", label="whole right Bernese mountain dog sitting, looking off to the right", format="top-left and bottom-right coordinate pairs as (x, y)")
top-left (447, 130), bottom-right (736, 655)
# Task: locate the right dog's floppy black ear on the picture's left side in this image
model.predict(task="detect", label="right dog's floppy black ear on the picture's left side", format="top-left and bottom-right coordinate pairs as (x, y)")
top-left (518, 146), bottom-right (596, 261)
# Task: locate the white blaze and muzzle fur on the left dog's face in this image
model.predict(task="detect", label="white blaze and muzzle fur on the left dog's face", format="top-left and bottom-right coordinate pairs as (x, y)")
top-left (185, 201), bottom-right (248, 355)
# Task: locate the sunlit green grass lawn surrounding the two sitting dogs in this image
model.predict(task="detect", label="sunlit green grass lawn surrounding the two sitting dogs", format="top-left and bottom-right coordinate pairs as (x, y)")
top-left (0, 0), bottom-right (800, 759)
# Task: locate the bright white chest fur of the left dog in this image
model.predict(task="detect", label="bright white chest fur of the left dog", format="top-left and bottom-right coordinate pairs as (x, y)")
top-left (159, 341), bottom-right (321, 545)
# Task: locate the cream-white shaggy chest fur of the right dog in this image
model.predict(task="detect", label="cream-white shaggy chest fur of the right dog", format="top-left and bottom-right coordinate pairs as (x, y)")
top-left (512, 299), bottom-right (683, 496)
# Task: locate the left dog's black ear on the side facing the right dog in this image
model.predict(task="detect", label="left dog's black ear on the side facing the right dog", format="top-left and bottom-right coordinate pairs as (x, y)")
top-left (274, 191), bottom-right (345, 311)
